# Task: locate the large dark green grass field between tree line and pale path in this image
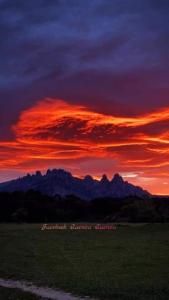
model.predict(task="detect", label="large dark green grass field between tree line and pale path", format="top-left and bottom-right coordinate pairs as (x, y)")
top-left (0, 224), bottom-right (169, 300)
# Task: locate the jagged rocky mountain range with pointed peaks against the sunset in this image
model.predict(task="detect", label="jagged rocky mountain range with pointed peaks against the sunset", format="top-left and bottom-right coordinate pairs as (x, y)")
top-left (0, 169), bottom-right (150, 200)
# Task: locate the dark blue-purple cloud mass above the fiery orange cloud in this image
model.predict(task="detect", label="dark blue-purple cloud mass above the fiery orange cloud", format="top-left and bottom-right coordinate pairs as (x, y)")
top-left (0, 0), bottom-right (169, 138)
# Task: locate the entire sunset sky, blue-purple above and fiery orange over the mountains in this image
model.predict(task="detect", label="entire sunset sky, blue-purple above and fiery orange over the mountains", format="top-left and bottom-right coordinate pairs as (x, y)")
top-left (0, 0), bottom-right (169, 195)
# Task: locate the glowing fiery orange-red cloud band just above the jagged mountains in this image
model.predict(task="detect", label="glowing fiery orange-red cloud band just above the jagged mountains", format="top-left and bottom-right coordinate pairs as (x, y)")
top-left (0, 99), bottom-right (169, 194)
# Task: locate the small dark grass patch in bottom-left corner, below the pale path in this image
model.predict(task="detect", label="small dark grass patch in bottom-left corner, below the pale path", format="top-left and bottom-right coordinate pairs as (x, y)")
top-left (0, 287), bottom-right (44, 300)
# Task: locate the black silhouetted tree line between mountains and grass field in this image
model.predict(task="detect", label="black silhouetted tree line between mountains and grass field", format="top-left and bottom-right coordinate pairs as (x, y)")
top-left (0, 190), bottom-right (169, 223)
